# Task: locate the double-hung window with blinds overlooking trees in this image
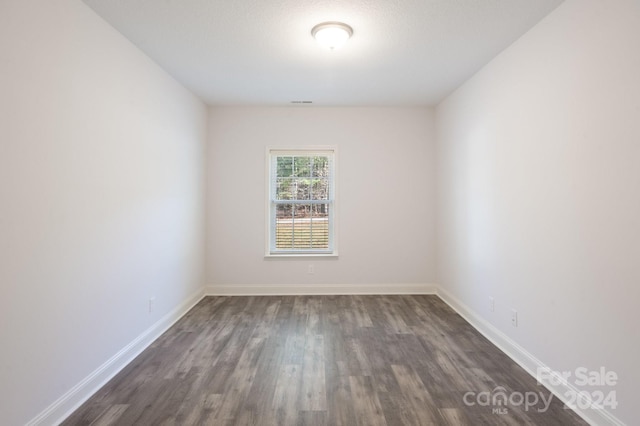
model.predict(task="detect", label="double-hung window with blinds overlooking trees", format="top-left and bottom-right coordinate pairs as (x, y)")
top-left (267, 148), bottom-right (336, 255)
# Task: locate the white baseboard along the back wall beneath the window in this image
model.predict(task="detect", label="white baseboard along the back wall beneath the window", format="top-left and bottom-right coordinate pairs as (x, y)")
top-left (205, 284), bottom-right (437, 296)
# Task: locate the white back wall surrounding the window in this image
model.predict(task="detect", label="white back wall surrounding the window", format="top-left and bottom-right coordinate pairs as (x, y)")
top-left (207, 107), bottom-right (435, 292)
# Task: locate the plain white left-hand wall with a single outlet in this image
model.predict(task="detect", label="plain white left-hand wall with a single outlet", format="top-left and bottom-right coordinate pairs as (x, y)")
top-left (0, 0), bottom-right (207, 425)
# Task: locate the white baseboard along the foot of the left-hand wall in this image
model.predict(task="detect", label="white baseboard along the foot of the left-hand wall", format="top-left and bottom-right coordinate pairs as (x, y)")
top-left (27, 290), bottom-right (204, 426)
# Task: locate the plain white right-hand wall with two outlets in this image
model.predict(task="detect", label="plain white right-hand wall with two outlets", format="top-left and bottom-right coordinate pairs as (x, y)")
top-left (436, 0), bottom-right (640, 424)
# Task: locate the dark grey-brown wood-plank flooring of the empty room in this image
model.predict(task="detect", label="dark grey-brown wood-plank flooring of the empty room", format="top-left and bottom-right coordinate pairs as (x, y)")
top-left (63, 296), bottom-right (585, 426)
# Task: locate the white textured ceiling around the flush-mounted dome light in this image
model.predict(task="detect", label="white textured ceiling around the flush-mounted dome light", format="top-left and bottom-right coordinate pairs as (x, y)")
top-left (85, 0), bottom-right (562, 106)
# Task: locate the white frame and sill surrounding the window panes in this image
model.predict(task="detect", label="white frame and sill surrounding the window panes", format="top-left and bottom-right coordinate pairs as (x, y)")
top-left (265, 145), bottom-right (338, 258)
